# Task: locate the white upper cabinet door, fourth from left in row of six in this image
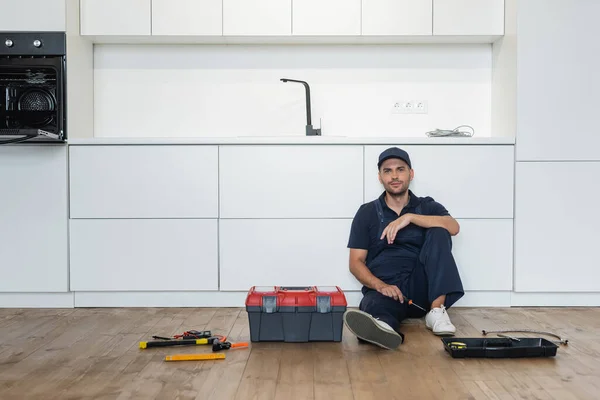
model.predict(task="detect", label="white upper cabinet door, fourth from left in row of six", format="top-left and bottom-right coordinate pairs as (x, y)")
top-left (292, 0), bottom-right (361, 36)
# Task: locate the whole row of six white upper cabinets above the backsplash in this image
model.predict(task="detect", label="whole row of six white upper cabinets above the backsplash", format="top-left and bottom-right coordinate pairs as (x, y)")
top-left (78, 0), bottom-right (504, 43)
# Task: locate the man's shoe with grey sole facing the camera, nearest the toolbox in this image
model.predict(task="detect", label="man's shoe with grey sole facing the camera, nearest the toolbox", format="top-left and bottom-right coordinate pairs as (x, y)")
top-left (344, 310), bottom-right (402, 350)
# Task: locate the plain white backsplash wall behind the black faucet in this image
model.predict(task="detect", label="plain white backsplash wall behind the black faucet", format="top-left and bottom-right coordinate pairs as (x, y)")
top-left (92, 44), bottom-right (492, 137)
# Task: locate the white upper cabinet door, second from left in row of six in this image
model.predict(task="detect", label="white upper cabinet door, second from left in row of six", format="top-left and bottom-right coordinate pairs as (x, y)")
top-left (152, 0), bottom-right (223, 36)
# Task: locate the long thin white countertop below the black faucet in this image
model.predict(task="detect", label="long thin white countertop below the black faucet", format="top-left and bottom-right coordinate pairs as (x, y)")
top-left (68, 136), bottom-right (515, 145)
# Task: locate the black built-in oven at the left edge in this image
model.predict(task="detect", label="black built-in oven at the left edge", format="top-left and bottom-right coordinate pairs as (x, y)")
top-left (0, 32), bottom-right (67, 144)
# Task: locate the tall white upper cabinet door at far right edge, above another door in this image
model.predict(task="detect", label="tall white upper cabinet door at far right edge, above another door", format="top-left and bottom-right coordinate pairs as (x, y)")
top-left (516, 0), bottom-right (600, 161)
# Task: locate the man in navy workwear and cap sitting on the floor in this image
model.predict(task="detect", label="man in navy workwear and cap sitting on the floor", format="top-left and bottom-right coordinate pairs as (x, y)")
top-left (344, 147), bottom-right (464, 349)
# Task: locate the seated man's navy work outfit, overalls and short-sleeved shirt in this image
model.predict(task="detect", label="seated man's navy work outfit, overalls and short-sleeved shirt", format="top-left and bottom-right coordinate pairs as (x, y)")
top-left (348, 191), bottom-right (464, 331)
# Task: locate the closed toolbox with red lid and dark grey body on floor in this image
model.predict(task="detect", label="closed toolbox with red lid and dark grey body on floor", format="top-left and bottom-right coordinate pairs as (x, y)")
top-left (246, 286), bottom-right (347, 342)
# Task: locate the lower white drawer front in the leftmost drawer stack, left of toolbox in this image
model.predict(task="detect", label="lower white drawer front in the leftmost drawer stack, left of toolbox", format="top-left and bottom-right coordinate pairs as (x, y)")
top-left (70, 219), bottom-right (218, 291)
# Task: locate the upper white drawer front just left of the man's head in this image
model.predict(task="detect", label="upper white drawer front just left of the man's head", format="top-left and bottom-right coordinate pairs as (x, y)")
top-left (219, 145), bottom-right (363, 218)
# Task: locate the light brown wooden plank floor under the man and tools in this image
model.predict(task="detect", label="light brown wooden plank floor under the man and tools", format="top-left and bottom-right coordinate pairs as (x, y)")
top-left (0, 308), bottom-right (600, 400)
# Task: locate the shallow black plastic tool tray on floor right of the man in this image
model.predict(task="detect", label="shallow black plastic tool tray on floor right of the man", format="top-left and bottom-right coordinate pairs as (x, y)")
top-left (442, 337), bottom-right (558, 358)
